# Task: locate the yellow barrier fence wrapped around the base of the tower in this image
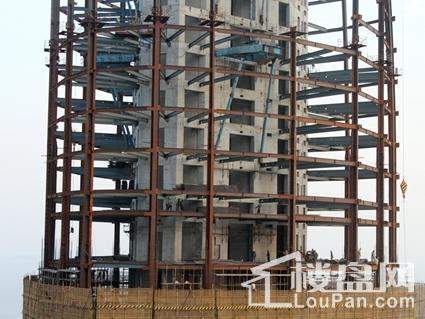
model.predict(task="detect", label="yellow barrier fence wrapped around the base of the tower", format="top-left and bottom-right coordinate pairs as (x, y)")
top-left (23, 278), bottom-right (425, 319)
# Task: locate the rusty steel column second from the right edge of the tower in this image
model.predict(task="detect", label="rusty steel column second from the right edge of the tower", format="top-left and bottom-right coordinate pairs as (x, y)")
top-left (376, 1), bottom-right (385, 262)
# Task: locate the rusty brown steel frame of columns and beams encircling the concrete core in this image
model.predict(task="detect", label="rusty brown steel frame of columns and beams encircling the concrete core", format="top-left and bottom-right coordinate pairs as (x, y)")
top-left (44, 0), bottom-right (398, 288)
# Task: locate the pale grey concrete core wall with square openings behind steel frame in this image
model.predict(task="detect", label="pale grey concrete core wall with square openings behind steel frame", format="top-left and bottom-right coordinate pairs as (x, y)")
top-left (130, 0), bottom-right (308, 272)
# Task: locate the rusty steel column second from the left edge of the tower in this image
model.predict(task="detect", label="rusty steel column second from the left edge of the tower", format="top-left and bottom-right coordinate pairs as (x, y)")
top-left (59, 0), bottom-right (74, 269)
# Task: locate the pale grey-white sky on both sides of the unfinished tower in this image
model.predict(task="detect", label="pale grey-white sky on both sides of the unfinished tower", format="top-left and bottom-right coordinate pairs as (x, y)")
top-left (0, 0), bottom-right (425, 319)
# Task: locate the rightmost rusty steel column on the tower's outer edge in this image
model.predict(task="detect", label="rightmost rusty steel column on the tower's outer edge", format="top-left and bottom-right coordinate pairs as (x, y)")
top-left (382, 0), bottom-right (397, 262)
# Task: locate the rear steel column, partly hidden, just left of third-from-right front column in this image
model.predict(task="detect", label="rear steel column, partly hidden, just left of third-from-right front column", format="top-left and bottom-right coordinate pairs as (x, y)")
top-left (341, 0), bottom-right (351, 260)
